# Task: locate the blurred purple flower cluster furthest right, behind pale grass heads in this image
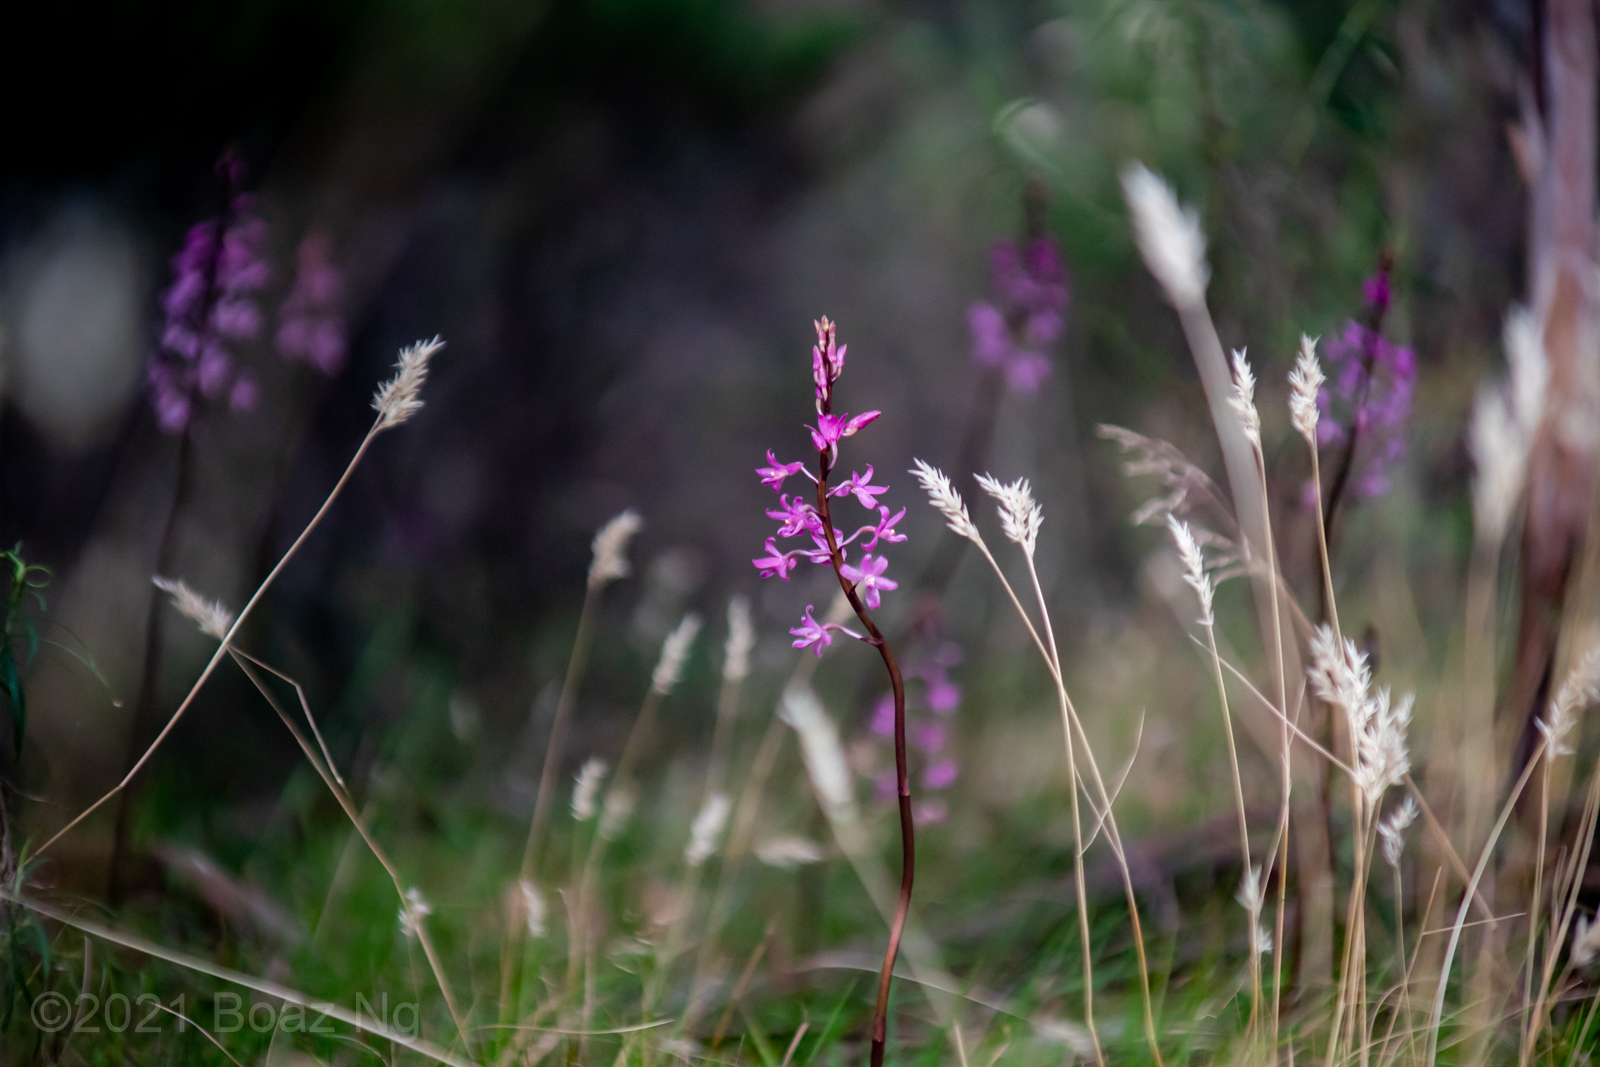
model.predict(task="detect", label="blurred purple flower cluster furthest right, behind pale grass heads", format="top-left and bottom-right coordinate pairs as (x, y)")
top-left (1317, 316), bottom-right (1416, 498)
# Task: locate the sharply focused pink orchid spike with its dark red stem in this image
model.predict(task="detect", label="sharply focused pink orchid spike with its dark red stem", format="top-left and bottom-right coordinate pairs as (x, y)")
top-left (750, 318), bottom-right (915, 1067)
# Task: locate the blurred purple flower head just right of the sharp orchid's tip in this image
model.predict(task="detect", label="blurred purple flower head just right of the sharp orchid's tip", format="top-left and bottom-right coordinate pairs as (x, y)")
top-left (966, 237), bottom-right (1067, 392)
